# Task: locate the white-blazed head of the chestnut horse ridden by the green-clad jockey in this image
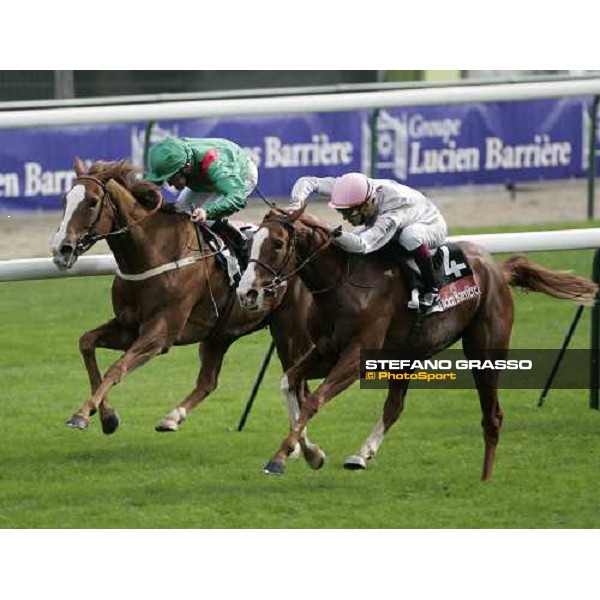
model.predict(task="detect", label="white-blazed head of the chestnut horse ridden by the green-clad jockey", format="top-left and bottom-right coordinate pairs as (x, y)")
top-left (50, 158), bottom-right (162, 271)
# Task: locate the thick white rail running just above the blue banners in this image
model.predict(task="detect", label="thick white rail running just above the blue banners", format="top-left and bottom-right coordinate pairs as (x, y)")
top-left (0, 78), bottom-right (600, 129)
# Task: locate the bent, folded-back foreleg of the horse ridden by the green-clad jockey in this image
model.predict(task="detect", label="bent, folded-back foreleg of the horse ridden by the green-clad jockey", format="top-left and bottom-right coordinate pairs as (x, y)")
top-left (79, 319), bottom-right (136, 435)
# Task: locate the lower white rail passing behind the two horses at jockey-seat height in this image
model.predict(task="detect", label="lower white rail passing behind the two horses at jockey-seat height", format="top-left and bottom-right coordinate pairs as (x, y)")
top-left (0, 229), bottom-right (600, 281)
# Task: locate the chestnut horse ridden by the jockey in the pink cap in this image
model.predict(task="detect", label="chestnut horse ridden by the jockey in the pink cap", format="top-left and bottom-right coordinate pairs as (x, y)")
top-left (238, 207), bottom-right (596, 480)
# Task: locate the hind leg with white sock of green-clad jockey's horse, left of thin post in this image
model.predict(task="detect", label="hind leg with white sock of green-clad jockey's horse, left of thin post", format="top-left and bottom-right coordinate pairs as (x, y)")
top-left (154, 341), bottom-right (231, 432)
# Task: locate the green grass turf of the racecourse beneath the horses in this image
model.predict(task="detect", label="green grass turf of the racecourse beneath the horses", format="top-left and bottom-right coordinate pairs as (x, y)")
top-left (0, 223), bottom-right (600, 528)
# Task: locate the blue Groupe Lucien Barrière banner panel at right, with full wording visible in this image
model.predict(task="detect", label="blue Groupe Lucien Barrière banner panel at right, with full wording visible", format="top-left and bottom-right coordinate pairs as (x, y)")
top-left (376, 98), bottom-right (589, 188)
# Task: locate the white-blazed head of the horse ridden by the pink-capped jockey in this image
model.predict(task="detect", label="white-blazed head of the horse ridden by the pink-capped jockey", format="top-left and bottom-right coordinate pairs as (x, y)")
top-left (237, 204), bottom-right (331, 310)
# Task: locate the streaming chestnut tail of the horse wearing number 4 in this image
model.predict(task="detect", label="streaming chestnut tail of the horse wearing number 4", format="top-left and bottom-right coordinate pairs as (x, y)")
top-left (502, 254), bottom-right (598, 306)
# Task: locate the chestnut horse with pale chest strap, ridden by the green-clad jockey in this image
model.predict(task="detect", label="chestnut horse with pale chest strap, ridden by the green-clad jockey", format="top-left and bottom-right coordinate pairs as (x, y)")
top-left (52, 159), bottom-right (324, 468)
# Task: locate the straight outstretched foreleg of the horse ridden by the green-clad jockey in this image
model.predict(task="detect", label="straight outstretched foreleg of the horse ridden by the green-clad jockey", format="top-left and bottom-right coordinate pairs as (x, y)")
top-left (67, 317), bottom-right (179, 429)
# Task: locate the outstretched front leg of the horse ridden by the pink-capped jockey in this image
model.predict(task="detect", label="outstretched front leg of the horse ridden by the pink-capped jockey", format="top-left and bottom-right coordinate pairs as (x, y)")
top-left (264, 342), bottom-right (361, 475)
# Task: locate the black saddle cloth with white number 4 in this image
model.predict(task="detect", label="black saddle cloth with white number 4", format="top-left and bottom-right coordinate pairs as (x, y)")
top-left (403, 243), bottom-right (481, 314)
